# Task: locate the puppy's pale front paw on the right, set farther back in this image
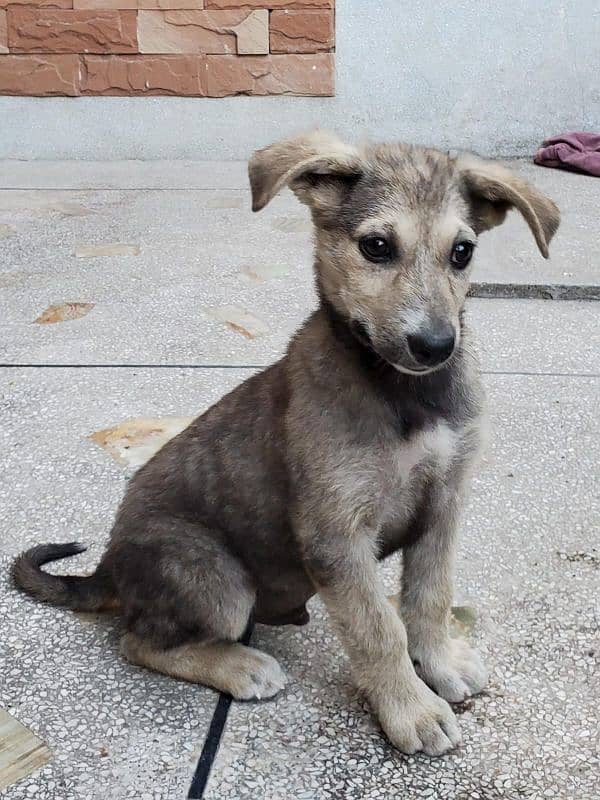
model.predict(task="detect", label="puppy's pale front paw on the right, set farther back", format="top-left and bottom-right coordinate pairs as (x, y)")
top-left (413, 638), bottom-right (488, 703)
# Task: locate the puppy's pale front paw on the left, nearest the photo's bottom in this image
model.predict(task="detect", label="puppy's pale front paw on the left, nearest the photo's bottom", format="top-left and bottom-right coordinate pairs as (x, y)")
top-left (375, 678), bottom-right (461, 756)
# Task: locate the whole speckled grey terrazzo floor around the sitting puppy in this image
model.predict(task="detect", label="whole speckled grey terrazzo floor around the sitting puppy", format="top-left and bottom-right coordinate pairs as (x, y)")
top-left (0, 159), bottom-right (600, 800)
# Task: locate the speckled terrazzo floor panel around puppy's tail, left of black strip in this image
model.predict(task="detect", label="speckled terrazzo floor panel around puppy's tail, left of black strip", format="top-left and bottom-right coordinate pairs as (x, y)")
top-left (0, 370), bottom-right (246, 800)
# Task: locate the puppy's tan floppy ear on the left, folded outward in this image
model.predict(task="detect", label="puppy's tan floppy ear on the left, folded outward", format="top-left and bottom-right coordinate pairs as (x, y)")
top-left (248, 130), bottom-right (362, 211)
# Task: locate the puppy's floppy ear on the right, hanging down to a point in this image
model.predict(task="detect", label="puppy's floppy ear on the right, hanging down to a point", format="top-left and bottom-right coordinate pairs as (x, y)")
top-left (458, 157), bottom-right (560, 258)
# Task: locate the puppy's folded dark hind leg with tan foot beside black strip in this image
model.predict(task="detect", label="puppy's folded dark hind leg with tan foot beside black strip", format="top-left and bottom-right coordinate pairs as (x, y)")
top-left (113, 517), bottom-right (285, 700)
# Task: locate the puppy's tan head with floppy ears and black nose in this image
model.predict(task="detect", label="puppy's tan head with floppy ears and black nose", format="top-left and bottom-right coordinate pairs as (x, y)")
top-left (249, 131), bottom-right (559, 374)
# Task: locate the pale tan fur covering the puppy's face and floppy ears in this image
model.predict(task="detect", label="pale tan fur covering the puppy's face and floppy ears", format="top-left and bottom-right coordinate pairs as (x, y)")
top-left (250, 131), bottom-right (559, 382)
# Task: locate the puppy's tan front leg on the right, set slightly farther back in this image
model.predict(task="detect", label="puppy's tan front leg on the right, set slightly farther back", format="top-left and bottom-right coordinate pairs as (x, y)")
top-left (401, 481), bottom-right (487, 702)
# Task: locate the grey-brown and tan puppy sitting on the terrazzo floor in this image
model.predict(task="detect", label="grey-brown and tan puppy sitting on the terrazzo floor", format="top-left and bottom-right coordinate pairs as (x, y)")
top-left (14, 131), bottom-right (559, 755)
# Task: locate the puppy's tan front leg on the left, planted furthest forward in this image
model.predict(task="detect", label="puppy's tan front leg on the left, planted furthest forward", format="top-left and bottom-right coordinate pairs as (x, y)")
top-left (306, 534), bottom-right (460, 755)
